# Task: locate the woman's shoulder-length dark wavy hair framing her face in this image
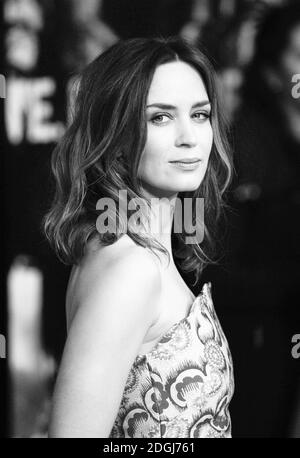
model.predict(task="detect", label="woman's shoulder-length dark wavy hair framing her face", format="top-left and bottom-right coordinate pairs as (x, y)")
top-left (42, 37), bottom-right (232, 281)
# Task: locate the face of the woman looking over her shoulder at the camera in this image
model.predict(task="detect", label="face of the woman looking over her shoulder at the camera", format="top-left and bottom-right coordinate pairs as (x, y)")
top-left (138, 61), bottom-right (213, 197)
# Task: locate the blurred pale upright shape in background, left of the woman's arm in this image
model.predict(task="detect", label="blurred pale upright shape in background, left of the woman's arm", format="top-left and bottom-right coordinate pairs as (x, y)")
top-left (7, 255), bottom-right (55, 437)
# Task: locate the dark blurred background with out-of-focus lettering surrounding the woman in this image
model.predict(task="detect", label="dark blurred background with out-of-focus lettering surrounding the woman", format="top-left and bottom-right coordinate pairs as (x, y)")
top-left (0, 0), bottom-right (300, 438)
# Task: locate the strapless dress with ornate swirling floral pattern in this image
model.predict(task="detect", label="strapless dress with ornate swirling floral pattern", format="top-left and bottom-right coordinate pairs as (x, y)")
top-left (109, 283), bottom-right (234, 438)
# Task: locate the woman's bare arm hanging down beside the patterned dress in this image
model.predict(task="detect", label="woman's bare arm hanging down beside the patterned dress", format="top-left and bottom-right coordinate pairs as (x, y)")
top-left (49, 247), bottom-right (160, 437)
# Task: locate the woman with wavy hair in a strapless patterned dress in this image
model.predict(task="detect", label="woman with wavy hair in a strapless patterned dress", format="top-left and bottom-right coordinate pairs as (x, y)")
top-left (45, 38), bottom-right (233, 437)
